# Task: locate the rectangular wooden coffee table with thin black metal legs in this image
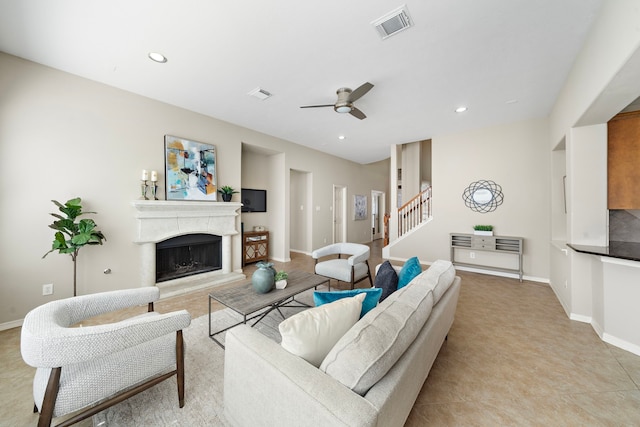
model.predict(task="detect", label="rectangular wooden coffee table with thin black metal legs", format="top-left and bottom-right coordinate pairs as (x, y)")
top-left (209, 271), bottom-right (329, 348)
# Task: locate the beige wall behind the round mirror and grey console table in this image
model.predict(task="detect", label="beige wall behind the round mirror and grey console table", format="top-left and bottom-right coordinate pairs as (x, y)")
top-left (390, 119), bottom-right (550, 279)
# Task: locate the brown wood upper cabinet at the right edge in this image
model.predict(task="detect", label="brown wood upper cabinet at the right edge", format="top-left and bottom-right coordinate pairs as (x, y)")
top-left (607, 111), bottom-right (640, 209)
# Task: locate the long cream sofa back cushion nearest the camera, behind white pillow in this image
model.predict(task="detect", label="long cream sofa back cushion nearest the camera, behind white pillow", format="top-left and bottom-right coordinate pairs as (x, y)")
top-left (320, 281), bottom-right (433, 395)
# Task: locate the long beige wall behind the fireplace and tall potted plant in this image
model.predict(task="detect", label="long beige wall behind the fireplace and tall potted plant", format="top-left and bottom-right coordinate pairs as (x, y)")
top-left (0, 53), bottom-right (388, 328)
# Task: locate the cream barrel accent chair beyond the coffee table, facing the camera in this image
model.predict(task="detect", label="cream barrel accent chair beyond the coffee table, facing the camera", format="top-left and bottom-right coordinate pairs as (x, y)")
top-left (311, 243), bottom-right (373, 290)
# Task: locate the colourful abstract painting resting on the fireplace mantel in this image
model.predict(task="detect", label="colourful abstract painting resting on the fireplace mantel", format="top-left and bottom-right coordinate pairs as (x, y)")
top-left (164, 135), bottom-right (218, 201)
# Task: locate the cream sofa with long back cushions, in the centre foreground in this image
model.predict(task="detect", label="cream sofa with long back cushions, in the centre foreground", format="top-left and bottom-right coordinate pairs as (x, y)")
top-left (224, 261), bottom-right (460, 427)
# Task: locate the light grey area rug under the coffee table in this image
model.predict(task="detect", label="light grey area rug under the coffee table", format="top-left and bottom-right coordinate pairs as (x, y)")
top-left (93, 290), bottom-right (313, 427)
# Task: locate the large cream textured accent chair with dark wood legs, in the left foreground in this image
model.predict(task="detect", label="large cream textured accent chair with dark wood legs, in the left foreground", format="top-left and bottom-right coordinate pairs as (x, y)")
top-left (20, 286), bottom-right (191, 426)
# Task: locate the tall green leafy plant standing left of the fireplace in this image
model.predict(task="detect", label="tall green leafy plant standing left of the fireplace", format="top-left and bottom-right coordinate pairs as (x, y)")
top-left (42, 197), bottom-right (107, 296)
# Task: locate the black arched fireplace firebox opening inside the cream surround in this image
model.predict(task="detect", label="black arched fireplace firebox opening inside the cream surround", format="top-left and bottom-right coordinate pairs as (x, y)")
top-left (156, 234), bottom-right (222, 283)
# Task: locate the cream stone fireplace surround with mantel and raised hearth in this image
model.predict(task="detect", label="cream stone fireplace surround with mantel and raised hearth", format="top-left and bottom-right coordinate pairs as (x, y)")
top-left (132, 200), bottom-right (245, 297)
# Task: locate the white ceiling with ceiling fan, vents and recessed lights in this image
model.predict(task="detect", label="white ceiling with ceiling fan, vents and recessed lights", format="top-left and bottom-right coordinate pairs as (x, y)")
top-left (0, 0), bottom-right (602, 163)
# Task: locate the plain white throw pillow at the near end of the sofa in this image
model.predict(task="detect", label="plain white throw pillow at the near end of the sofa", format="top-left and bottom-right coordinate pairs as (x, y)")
top-left (278, 293), bottom-right (366, 368)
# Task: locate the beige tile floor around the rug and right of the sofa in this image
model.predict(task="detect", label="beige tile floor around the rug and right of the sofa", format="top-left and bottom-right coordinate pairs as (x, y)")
top-left (0, 241), bottom-right (640, 427)
